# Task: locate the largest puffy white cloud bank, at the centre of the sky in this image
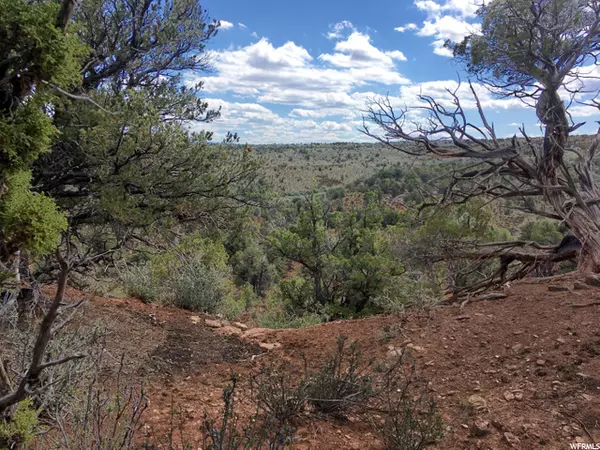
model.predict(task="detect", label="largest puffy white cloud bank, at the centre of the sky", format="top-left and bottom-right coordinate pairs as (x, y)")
top-left (186, 33), bottom-right (409, 109)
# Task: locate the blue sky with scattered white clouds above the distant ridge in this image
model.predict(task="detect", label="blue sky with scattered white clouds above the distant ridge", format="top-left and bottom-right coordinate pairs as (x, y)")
top-left (185, 0), bottom-right (596, 144)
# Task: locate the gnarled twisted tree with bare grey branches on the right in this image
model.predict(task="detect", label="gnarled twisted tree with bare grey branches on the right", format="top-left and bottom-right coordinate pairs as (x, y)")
top-left (362, 0), bottom-right (600, 273)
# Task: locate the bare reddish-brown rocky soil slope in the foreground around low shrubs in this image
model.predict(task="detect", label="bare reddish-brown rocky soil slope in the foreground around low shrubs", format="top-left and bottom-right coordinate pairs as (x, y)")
top-left (44, 275), bottom-right (600, 450)
